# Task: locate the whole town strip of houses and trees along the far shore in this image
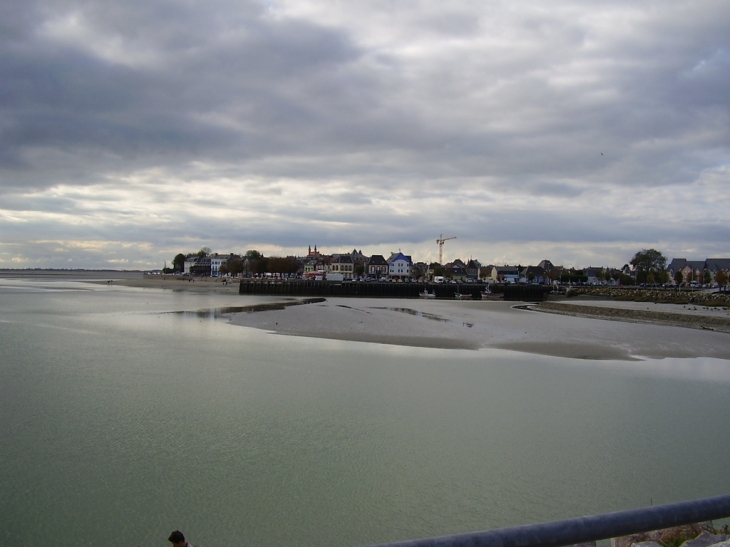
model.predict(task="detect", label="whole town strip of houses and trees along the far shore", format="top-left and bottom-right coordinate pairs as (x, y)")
top-left (163, 245), bottom-right (730, 287)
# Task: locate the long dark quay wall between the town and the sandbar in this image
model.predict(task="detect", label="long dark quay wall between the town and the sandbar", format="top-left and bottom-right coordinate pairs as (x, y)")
top-left (238, 279), bottom-right (550, 301)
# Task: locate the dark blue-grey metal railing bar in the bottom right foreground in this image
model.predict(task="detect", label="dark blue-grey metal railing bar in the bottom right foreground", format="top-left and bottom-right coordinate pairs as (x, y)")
top-left (370, 495), bottom-right (730, 547)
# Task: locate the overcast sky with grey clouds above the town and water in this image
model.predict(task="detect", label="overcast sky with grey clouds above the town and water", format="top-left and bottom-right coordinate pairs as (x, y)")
top-left (0, 0), bottom-right (730, 269)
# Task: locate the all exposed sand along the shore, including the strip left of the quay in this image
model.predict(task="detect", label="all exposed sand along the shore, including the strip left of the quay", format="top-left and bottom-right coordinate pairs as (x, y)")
top-left (98, 276), bottom-right (730, 360)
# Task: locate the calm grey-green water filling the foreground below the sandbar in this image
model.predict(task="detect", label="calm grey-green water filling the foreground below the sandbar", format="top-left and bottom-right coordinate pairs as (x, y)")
top-left (0, 280), bottom-right (730, 547)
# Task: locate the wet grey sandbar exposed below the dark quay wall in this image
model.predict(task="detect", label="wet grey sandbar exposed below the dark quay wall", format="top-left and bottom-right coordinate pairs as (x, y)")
top-left (226, 298), bottom-right (730, 360)
